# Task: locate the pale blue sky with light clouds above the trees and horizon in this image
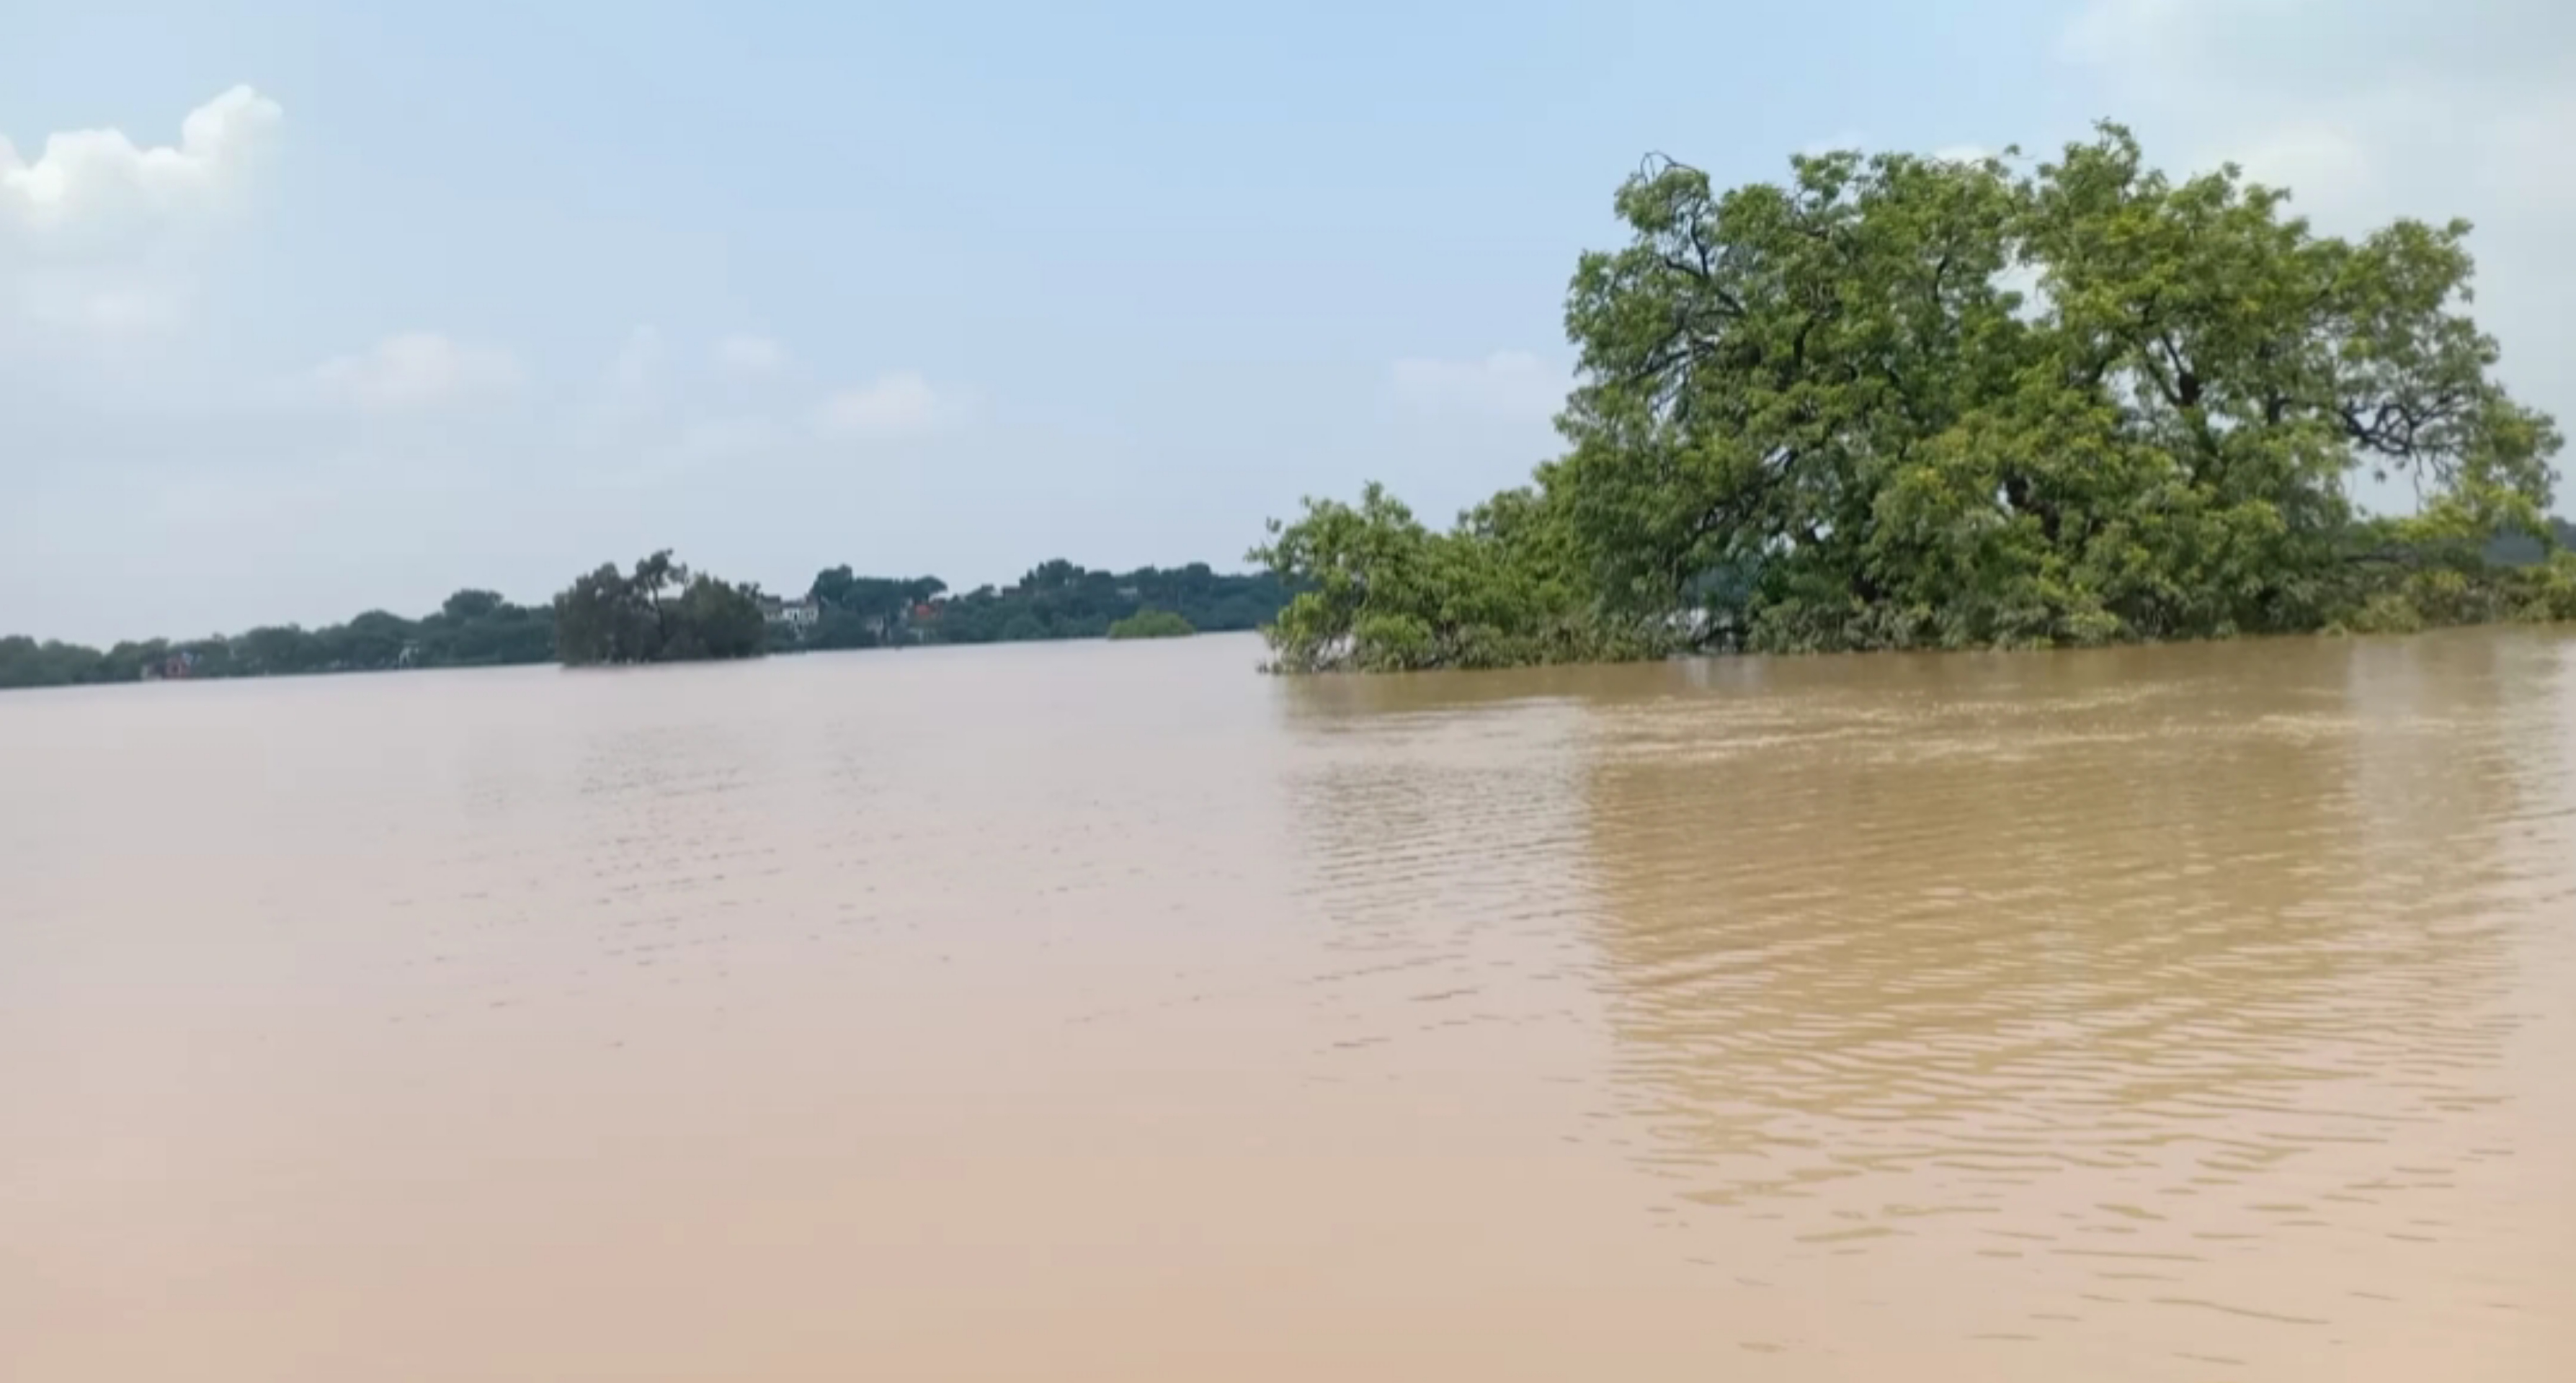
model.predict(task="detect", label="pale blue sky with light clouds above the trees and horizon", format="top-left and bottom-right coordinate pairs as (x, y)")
top-left (0, 0), bottom-right (2576, 639)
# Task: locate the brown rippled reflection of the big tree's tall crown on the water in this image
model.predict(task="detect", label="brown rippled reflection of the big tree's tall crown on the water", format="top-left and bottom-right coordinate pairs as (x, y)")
top-left (1587, 644), bottom-right (2514, 1205)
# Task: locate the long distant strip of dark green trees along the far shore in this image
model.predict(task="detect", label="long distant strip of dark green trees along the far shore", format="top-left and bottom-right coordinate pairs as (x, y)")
top-left (0, 551), bottom-right (1291, 690)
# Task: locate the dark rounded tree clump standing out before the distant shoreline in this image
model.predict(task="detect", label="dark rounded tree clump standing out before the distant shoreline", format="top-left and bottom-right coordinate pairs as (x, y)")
top-left (554, 549), bottom-right (765, 667)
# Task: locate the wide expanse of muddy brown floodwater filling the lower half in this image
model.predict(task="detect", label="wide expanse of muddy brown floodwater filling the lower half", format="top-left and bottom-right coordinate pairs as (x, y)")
top-left (0, 631), bottom-right (2576, 1383)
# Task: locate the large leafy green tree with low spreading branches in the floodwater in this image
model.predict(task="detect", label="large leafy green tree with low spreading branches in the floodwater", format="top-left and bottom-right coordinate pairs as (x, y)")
top-left (1254, 126), bottom-right (2576, 667)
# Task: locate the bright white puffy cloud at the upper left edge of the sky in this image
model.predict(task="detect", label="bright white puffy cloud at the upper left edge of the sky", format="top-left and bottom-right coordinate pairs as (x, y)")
top-left (0, 85), bottom-right (283, 234)
